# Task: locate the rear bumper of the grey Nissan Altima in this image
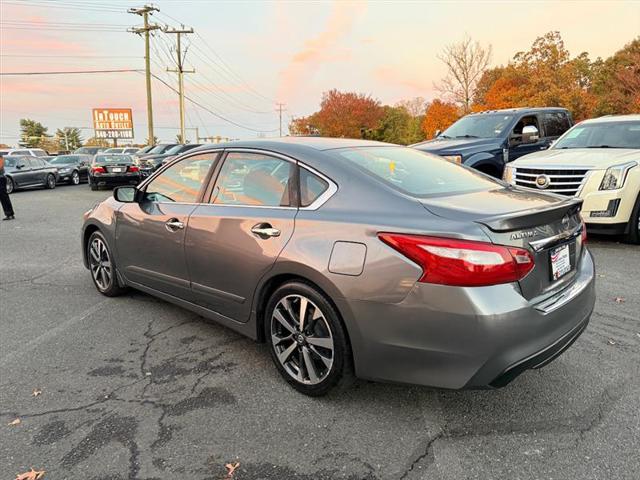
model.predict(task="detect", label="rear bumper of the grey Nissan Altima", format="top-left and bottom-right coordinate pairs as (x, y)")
top-left (338, 251), bottom-right (595, 389)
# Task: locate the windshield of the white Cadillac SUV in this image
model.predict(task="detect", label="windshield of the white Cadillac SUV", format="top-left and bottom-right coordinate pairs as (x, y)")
top-left (553, 121), bottom-right (640, 150)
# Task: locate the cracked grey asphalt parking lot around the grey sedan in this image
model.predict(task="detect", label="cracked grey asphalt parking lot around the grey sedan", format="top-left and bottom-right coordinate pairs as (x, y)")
top-left (0, 185), bottom-right (640, 480)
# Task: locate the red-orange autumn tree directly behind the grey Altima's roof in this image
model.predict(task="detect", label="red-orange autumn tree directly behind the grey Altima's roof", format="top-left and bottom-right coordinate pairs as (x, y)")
top-left (312, 89), bottom-right (384, 138)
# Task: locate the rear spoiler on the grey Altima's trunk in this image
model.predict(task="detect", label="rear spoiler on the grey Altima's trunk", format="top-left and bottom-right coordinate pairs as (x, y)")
top-left (476, 198), bottom-right (582, 232)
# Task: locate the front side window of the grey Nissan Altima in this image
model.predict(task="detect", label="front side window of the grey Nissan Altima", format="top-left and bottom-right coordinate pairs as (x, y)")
top-left (145, 153), bottom-right (218, 203)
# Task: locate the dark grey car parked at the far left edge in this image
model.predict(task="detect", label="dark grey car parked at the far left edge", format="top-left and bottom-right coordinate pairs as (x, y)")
top-left (4, 155), bottom-right (58, 193)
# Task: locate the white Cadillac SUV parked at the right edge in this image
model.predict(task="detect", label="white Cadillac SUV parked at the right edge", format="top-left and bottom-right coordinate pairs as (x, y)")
top-left (505, 115), bottom-right (640, 243)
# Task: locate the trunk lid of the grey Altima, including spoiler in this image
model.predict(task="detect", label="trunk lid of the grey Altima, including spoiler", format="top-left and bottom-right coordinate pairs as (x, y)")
top-left (421, 187), bottom-right (583, 299)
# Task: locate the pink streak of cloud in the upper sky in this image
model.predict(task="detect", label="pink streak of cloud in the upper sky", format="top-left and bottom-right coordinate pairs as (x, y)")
top-left (278, 1), bottom-right (366, 101)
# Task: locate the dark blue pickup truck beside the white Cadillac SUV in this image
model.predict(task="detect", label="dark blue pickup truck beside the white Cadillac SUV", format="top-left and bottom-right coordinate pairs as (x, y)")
top-left (412, 108), bottom-right (573, 178)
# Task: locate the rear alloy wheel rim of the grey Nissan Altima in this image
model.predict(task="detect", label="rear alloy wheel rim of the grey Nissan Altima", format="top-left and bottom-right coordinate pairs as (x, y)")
top-left (271, 295), bottom-right (334, 385)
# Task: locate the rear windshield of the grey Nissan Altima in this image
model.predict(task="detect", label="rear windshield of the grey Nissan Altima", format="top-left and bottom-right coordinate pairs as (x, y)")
top-left (335, 147), bottom-right (501, 197)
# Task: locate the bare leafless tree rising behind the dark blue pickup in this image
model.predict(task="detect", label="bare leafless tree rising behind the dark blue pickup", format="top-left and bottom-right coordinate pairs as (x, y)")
top-left (435, 36), bottom-right (491, 113)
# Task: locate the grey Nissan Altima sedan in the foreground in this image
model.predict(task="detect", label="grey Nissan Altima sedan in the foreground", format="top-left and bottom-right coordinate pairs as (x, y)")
top-left (82, 138), bottom-right (595, 395)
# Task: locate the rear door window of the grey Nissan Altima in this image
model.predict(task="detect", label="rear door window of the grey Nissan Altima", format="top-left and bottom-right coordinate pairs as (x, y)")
top-left (212, 152), bottom-right (295, 207)
